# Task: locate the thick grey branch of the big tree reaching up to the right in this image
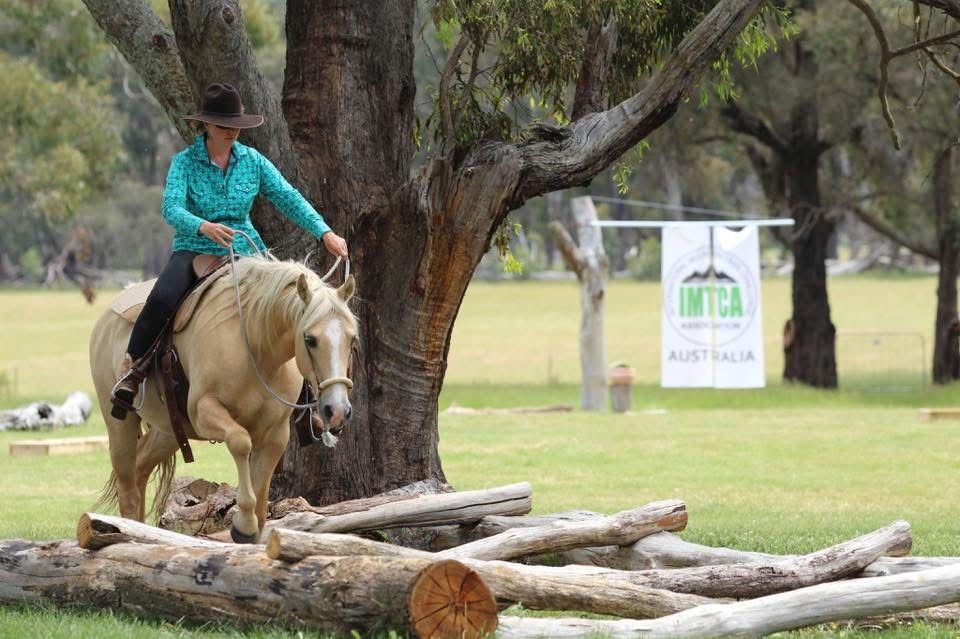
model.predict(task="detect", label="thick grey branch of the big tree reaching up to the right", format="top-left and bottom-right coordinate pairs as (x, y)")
top-left (512, 0), bottom-right (762, 200)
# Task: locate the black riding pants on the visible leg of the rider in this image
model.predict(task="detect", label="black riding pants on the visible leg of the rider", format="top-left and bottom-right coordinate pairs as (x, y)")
top-left (127, 251), bottom-right (200, 361)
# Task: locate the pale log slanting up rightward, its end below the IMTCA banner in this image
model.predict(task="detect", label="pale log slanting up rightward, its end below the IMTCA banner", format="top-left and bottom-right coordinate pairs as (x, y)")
top-left (437, 499), bottom-right (687, 559)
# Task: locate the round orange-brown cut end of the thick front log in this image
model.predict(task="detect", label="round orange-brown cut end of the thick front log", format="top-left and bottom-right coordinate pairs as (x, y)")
top-left (408, 559), bottom-right (497, 639)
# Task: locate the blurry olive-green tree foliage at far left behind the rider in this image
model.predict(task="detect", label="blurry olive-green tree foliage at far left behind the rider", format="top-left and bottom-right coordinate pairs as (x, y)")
top-left (0, 0), bottom-right (122, 278)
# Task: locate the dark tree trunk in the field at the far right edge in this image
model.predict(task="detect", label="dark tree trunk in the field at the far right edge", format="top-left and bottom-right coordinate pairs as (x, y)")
top-left (933, 147), bottom-right (960, 384)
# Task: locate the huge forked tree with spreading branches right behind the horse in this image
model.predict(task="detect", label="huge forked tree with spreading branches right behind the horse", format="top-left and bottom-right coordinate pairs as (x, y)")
top-left (84, 0), bottom-right (767, 501)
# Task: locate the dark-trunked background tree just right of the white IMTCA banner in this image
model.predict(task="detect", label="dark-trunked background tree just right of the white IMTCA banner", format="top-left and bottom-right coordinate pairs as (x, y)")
top-left (722, 0), bottom-right (900, 388)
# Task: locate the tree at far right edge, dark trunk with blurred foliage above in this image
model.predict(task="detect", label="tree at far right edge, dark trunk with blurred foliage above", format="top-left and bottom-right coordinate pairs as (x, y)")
top-left (848, 0), bottom-right (960, 384)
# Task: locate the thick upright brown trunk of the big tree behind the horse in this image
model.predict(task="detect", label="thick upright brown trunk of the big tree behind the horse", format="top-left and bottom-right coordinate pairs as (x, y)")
top-left (259, 0), bottom-right (438, 503)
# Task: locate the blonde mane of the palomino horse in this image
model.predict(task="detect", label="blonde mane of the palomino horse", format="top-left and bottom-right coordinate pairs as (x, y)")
top-left (236, 253), bottom-right (357, 350)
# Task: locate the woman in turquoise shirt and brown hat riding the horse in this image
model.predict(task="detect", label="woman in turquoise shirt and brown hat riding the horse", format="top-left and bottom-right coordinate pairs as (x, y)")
top-left (110, 84), bottom-right (347, 420)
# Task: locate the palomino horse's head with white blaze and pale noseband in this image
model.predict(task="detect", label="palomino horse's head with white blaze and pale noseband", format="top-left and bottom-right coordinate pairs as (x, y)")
top-left (294, 275), bottom-right (357, 435)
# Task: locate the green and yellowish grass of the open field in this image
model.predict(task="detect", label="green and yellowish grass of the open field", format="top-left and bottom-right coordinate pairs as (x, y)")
top-left (0, 277), bottom-right (960, 638)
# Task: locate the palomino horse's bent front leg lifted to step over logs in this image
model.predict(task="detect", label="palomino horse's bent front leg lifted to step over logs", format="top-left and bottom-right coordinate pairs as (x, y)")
top-left (197, 395), bottom-right (260, 543)
